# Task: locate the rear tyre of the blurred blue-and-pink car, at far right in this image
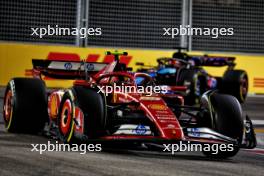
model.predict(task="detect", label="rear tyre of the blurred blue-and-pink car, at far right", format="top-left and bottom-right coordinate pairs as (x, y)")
top-left (221, 70), bottom-right (248, 103)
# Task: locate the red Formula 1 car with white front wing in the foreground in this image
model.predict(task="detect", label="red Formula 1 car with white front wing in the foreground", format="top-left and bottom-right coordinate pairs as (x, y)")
top-left (3, 53), bottom-right (256, 158)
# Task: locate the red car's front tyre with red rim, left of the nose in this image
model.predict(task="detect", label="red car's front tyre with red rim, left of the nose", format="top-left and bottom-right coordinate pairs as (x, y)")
top-left (58, 86), bottom-right (107, 143)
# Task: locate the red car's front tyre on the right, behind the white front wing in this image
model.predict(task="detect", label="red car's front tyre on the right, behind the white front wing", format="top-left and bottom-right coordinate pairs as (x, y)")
top-left (203, 93), bottom-right (244, 158)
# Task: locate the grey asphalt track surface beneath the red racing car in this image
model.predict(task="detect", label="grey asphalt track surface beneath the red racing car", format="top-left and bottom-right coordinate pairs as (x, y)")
top-left (0, 88), bottom-right (264, 176)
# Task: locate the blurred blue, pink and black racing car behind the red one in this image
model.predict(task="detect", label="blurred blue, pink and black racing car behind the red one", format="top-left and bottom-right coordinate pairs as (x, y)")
top-left (137, 52), bottom-right (248, 105)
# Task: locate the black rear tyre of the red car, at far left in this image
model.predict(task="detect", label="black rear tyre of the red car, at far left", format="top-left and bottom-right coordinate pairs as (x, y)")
top-left (3, 78), bottom-right (48, 133)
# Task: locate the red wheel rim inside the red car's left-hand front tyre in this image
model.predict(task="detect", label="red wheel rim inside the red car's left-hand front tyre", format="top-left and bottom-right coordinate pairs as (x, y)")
top-left (60, 100), bottom-right (72, 135)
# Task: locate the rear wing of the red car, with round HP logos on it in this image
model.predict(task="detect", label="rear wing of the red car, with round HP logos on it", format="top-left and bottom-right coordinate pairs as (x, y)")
top-left (27, 59), bottom-right (108, 79)
